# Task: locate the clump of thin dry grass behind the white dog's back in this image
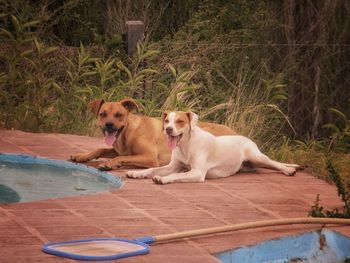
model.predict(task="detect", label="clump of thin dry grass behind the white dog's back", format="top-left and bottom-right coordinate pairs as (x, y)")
top-left (203, 69), bottom-right (294, 147)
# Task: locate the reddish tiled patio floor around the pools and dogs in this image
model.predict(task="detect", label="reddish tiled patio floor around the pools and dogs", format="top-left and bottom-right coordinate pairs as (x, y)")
top-left (0, 130), bottom-right (350, 263)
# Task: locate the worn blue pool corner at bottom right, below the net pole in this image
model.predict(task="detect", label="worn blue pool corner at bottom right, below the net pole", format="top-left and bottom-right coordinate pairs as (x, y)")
top-left (215, 229), bottom-right (350, 263)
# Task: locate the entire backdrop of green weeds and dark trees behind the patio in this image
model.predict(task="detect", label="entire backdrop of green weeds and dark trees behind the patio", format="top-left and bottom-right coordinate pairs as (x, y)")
top-left (0, 0), bottom-right (350, 192)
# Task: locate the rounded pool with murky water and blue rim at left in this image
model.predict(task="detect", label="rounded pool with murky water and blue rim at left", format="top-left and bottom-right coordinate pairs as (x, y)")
top-left (0, 153), bottom-right (122, 203)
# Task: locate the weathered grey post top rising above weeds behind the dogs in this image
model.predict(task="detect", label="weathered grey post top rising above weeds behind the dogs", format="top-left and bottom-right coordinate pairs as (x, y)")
top-left (126, 21), bottom-right (145, 57)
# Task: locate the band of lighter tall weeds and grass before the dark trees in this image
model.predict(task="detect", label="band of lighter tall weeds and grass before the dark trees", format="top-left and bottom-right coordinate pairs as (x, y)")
top-left (0, 12), bottom-right (350, 189)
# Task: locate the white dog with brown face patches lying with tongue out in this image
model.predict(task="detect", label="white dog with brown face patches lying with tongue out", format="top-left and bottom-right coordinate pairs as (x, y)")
top-left (127, 112), bottom-right (299, 184)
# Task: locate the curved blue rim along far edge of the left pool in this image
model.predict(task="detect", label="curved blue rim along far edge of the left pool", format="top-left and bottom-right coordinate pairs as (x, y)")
top-left (0, 152), bottom-right (124, 188)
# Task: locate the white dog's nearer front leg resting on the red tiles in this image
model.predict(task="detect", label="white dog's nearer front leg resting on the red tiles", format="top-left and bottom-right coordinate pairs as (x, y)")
top-left (152, 168), bottom-right (206, 184)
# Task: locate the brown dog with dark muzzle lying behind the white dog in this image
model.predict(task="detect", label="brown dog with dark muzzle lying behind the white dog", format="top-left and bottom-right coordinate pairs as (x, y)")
top-left (71, 99), bottom-right (235, 170)
